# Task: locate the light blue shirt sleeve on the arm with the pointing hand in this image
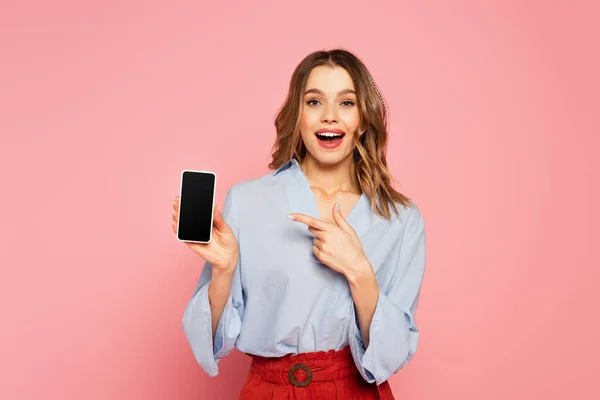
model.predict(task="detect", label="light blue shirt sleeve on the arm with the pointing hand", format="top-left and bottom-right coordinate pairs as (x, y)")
top-left (349, 205), bottom-right (425, 385)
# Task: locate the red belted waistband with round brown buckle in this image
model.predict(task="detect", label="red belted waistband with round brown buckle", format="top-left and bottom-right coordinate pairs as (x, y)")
top-left (250, 346), bottom-right (359, 387)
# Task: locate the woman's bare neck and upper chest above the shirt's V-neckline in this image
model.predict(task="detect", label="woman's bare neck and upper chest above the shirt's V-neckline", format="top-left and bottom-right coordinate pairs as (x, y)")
top-left (300, 153), bottom-right (361, 194)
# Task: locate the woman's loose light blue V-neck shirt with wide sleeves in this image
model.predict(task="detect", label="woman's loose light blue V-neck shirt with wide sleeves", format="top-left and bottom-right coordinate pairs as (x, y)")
top-left (183, 159), bottom-right (425, 384)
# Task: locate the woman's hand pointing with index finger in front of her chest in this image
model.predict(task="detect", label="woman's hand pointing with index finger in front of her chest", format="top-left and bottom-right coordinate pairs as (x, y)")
top-left (288, 206), bottom-right (370, 278)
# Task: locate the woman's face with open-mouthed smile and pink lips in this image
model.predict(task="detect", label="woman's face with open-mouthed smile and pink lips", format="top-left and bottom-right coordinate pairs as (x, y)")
top-left (300, 66), bottom-right (360, 165)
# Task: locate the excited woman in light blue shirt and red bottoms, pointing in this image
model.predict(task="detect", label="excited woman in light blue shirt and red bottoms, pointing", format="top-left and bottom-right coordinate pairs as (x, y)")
top-left (173, 50), bottom-right (425, 400)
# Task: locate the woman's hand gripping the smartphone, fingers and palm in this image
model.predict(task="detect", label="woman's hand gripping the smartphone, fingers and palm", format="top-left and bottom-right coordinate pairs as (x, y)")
top-left (172, 196), bottom-right (239, 274)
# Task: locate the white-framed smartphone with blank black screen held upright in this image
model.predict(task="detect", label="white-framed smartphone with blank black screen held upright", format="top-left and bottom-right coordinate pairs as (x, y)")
top-left (177, 169), bottom-right (217, 243)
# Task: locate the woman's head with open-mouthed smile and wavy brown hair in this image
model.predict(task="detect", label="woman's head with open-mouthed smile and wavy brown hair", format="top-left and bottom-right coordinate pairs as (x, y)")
top-left (269, 50), bottom-right (410, 218)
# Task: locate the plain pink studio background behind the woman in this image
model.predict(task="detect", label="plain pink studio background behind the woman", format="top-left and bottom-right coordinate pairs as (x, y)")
top-left (0, 0), bottom-right (600, 400)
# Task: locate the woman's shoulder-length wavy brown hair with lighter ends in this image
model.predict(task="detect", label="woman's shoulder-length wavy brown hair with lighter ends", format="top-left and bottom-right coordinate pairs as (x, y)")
top-left (269, 49), bottom-right (410, 219)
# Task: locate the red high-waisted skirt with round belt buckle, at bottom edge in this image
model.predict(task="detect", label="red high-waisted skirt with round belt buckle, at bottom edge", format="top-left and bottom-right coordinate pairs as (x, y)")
top-left (240, 346), bottom-right (394, 400)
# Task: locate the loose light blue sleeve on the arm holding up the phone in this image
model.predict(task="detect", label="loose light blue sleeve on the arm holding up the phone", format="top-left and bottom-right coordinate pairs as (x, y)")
top-left (183, 188), bottom-right (244, 376)
